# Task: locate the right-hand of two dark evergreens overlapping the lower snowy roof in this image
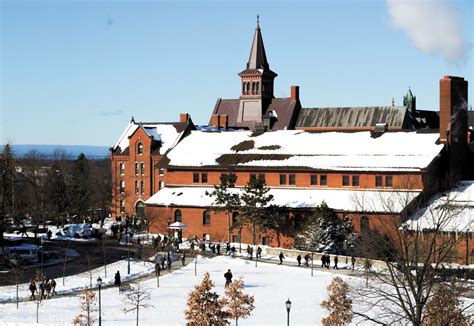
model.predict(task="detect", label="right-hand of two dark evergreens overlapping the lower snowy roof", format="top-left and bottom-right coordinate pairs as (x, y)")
top-left (240, 174), bottom-right (273, 245)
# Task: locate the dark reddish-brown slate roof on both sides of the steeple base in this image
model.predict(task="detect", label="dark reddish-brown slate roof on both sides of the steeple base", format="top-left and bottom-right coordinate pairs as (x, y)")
top-left (209, 97), bottom-right (299, 130)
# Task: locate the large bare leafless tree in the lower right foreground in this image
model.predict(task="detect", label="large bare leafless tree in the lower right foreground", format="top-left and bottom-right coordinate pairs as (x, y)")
top-left (354, 182), bottom-right (470, 325)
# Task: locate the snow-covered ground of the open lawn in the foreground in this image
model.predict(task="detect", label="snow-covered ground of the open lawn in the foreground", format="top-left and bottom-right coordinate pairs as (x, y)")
top-left (0, 256), bottom-right (472, 325)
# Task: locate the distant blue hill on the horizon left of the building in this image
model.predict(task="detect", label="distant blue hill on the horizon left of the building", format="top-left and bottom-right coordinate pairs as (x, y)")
top-left (5, 144), bottom-right (109, 159)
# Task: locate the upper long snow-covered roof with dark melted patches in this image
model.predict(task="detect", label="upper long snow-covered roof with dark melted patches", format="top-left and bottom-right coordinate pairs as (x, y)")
top-left (168, 130), bottom-right (443, 171)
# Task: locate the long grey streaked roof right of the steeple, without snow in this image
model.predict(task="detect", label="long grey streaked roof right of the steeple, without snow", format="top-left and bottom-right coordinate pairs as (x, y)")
top-left (295, 106), bottom-right (411, 130)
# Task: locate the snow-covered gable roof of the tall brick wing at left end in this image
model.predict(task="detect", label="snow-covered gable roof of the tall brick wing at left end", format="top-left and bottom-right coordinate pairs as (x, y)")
top-left (112, 120), bottom-right (189, 155)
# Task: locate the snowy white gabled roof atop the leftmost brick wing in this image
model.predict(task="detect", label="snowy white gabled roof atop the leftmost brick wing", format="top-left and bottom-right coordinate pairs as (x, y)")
top-left (113, 121), bottom-right (181, 155)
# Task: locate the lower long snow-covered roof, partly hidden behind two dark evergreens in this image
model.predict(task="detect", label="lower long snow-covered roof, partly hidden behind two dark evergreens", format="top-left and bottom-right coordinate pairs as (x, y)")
top-left (145, 187), bottom-right (419, 213)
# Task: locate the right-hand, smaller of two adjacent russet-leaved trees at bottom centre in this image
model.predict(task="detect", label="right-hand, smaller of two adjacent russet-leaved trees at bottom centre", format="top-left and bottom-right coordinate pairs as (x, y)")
top-left (225, 277), bottom-right (255, 326)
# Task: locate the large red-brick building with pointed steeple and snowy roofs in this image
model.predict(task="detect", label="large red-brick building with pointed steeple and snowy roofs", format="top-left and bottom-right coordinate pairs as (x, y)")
top-left (111, 22), bottom-right (473, 260)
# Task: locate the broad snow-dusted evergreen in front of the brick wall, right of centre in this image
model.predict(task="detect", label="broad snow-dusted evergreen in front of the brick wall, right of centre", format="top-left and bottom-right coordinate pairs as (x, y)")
top-left (296, 202), bottom-right (354, 252)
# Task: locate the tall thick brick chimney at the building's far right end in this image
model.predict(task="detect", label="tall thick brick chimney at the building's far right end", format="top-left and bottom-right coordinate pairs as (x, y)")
top-left (439, 76), bottom-right (468, 144)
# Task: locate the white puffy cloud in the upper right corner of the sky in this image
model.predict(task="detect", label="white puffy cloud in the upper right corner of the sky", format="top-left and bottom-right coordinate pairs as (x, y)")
top-left (387, 0), bottom-right (467, 62)
